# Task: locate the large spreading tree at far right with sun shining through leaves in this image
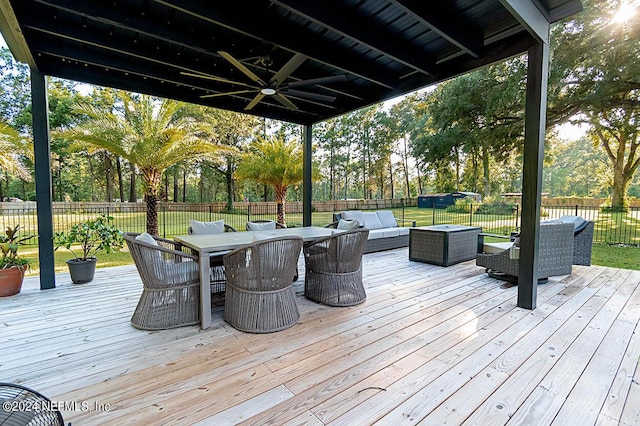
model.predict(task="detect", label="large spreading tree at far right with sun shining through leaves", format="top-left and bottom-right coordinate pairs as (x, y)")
top-left (549, 0), bottom-right (640, 210)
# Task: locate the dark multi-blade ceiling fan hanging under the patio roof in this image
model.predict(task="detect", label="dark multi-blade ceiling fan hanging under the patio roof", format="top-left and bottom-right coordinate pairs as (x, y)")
top-left (181, 50), bottom-right (347, 111)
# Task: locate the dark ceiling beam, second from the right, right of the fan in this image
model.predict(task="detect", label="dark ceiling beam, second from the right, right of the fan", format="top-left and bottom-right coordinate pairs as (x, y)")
top-left (272, 0), bottom-right (437, 75)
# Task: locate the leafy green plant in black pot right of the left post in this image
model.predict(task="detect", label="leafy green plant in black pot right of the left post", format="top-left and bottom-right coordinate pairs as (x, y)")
top-left (53, 214), bottom-right (124, 284)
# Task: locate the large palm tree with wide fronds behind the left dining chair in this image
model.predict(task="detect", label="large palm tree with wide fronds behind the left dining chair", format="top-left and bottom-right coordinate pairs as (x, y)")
top-left (61, 91), bottom-right (218, 235)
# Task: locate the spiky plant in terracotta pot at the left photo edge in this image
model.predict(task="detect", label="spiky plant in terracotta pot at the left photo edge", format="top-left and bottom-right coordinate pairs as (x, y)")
top-left (0, 225), bottom-right (31, 297)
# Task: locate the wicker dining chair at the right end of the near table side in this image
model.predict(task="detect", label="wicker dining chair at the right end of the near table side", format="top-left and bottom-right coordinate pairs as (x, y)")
top-left (304, 229), bottom-right (369, 306)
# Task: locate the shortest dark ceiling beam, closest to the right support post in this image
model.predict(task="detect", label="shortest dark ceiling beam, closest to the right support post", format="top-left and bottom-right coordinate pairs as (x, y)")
top-left (391, 0), bottom-right (484, 58)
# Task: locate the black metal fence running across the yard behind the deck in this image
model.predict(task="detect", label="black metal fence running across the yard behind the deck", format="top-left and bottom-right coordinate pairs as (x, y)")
top-left (0, 200), bottom-right (640, 247)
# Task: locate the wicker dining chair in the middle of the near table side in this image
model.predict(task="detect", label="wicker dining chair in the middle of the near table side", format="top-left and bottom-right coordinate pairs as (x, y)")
top-left (224, 236), bottom-right (303, 333)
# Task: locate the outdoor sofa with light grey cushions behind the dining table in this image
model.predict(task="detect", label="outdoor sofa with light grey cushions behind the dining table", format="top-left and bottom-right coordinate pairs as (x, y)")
top-left (330, 210), bottom-right (416, 253)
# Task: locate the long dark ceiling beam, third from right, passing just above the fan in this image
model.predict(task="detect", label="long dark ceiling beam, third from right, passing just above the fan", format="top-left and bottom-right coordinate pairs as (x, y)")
top-left (152, 0), bottom-right (397, 89)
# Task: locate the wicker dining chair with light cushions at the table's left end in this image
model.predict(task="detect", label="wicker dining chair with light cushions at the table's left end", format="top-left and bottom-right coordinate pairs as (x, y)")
top-left (123, 233), bottom-right (212, 330)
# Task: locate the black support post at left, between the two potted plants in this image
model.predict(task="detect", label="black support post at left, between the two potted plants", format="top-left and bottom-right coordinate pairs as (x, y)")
top-left (31, 69), bottom-right (56, 290)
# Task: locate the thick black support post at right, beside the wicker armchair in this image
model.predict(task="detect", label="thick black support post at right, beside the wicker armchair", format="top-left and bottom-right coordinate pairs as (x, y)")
top-left (518, 42), bottom-right (549, 309)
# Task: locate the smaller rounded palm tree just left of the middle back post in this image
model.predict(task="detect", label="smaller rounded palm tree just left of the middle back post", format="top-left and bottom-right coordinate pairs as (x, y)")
top-left (236, 137), bottom-right (317, 225)
